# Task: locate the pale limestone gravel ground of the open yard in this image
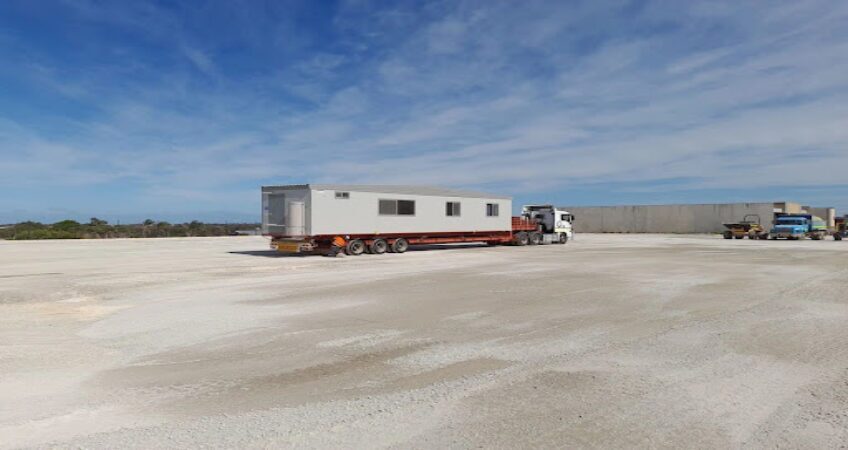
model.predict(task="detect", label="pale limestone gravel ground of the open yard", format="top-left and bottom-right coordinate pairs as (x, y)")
top-left (0, 235), bottom-right (848, 449)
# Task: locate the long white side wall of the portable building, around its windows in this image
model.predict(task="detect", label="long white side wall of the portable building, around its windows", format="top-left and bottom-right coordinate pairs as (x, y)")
top-left (309, 190), bottom-right (512, 236)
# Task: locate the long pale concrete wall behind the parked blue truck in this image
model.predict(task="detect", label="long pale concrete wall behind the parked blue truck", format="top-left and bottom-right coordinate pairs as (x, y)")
top-left (562, 202), bottom-right (836, 233)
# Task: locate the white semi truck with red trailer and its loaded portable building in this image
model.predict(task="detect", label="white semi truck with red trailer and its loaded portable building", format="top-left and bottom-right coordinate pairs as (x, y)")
top-left (262, 184), bottom-right (574, 255)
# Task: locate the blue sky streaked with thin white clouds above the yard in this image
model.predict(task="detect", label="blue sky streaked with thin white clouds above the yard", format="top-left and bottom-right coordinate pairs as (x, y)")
top-left (0, 0), bottom-right (848, 222)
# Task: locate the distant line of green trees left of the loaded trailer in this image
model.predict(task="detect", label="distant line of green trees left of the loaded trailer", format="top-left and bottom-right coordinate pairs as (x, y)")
top-left (0, 217), bottom-right (259, 240)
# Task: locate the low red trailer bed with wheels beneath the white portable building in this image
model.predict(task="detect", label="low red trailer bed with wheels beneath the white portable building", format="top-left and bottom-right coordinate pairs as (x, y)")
top-left (271, 217), bottom-right (541, 255)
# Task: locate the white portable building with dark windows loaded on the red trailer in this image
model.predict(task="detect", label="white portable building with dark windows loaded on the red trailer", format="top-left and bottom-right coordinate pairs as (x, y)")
top-left (262, 184), bottom-right (512, 237)
